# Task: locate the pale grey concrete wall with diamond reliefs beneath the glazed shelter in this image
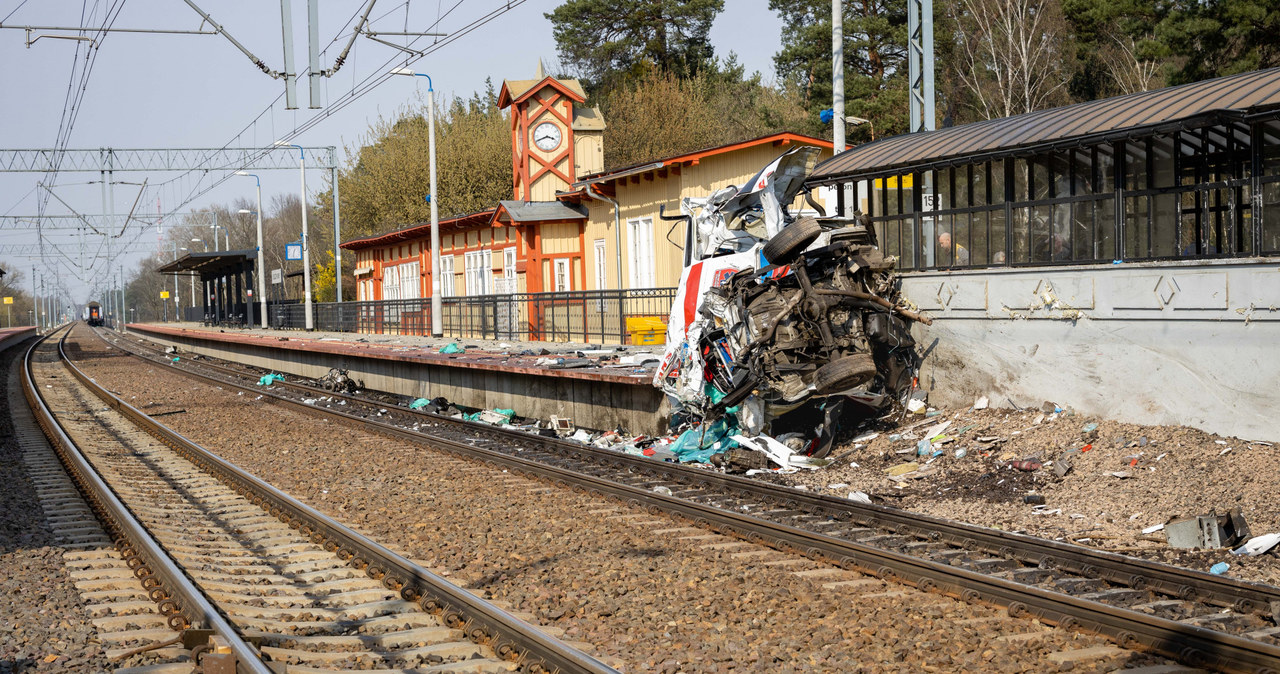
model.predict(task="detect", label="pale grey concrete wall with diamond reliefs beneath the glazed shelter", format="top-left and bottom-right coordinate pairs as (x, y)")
top-left (902, 258), bottom-right (1280, 440)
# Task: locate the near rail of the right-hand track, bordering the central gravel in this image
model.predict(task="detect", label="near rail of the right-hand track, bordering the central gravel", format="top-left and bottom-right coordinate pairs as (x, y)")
top-left (94, 329), bottom-right (1280, 674)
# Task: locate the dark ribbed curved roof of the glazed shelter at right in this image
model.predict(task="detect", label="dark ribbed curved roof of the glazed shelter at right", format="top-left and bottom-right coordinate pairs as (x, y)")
top-left (810, 68), bottom-right (1280, 182)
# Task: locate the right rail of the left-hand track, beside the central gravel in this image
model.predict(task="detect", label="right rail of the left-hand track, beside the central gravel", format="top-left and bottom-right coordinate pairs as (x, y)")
top-left (67, 329), bottom-right (617, 674)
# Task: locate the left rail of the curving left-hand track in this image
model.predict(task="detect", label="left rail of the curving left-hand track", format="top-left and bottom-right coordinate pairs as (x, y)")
top-left (22, 329), bottom-right (271, 674)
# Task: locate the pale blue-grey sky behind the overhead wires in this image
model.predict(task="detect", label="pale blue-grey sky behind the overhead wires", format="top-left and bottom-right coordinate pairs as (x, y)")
top-left (0, 0), bottom-right (781, 302)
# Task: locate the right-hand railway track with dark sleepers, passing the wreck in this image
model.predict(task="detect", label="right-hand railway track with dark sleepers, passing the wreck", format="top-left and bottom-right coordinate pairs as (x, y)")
top-left (94, 324), bottom-right (1280, 671)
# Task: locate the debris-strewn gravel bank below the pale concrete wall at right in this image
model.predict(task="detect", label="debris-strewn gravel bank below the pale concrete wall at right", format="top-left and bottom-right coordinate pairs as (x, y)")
top-left (771, 409), bottom-right (1280, 584)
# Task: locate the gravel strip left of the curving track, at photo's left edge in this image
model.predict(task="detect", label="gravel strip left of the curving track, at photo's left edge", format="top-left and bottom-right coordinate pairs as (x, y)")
top-left (0, 350), bottom-right (113, 674)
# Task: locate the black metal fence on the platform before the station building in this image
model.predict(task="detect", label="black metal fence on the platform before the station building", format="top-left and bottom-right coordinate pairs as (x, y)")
top-left (270, 288), bottom-right (676, 344)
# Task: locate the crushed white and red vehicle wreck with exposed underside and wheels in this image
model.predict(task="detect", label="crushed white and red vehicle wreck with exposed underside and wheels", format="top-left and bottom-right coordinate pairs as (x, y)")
top-left (654, 147), bottom-right (929, 464)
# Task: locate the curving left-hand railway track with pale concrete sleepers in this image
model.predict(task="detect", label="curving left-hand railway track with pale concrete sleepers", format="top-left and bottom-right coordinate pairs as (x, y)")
top-left (22, 324), bottom-right (613, 674)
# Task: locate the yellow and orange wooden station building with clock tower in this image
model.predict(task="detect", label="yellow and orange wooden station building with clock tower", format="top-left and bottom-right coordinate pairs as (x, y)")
top-left (342, 65), bottom-right (832, 303)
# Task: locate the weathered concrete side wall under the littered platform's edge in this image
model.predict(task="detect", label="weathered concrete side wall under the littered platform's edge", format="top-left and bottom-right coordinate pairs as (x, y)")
top-left (129, 325), bottom-right (667, 435)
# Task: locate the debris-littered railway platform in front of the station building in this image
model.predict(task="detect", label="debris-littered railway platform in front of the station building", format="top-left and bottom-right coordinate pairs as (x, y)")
top-left (127, 322), bottom-right (668, 435)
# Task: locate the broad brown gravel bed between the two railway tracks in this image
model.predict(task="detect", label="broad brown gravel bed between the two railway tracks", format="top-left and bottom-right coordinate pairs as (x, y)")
top-left (70, 326), bottom-right (1172, 671)
